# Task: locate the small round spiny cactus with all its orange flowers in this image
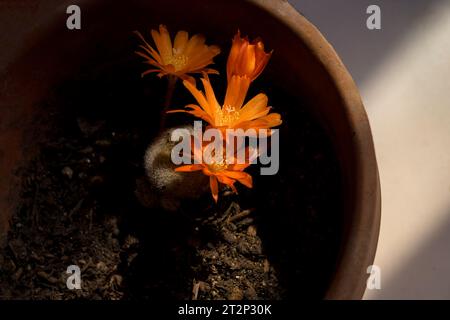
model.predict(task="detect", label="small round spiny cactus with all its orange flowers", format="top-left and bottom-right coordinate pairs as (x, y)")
top-left (137, 26), bottom-right (282, 210)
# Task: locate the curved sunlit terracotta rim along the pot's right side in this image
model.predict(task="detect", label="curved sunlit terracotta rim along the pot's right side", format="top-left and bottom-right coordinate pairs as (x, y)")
top-left (246, 0), bottom-right (381, 299)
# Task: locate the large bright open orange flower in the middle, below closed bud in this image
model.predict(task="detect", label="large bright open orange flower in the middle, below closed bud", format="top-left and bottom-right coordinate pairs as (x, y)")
top-left (169, 74), bottom-right (281, 130)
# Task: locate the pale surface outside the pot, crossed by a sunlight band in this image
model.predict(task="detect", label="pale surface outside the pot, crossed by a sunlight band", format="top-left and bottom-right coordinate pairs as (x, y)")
top-left (290, 0), bottom-right (450, 299)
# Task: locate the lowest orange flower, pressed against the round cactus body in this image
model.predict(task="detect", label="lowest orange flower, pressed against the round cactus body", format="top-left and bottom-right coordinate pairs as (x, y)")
top-left (175, 148), bottom-right (253, 202)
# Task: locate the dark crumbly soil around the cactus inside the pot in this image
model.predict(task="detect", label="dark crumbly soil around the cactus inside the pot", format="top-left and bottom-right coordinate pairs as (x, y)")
top-left (0, 52), bottom-right (342, 299)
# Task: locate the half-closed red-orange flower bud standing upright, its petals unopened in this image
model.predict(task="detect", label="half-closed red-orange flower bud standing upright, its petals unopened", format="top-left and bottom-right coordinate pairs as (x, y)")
top-left (227, 31), bottom-right (272, 81)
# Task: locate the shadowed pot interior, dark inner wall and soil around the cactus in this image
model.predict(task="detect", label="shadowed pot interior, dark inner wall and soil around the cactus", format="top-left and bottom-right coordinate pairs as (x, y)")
top-left (0, 0), bottom-right (350, 299)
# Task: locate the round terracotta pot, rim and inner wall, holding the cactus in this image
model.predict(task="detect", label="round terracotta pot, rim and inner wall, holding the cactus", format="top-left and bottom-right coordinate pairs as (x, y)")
top-left (0, 0), bottom-right (380, 299)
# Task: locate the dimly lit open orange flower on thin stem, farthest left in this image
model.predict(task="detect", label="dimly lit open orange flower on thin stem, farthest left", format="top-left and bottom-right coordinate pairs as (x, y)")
top-left (135, 25), bottom-right (220, 81)
